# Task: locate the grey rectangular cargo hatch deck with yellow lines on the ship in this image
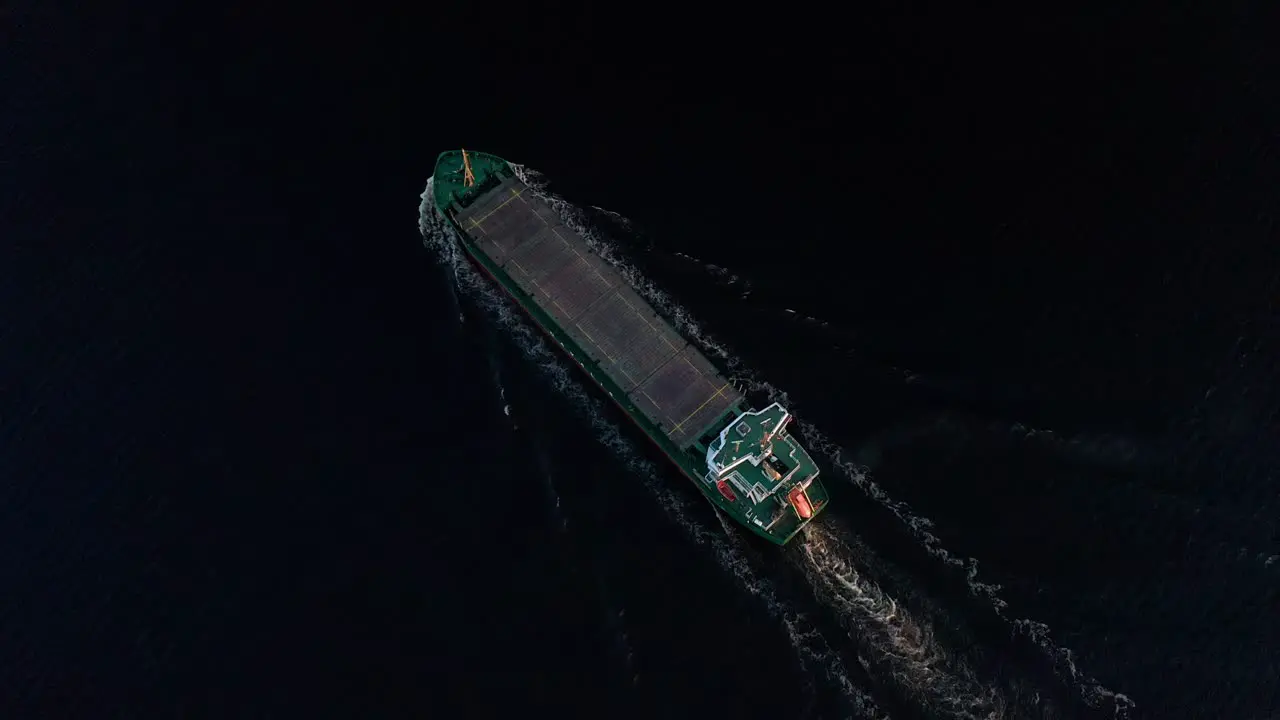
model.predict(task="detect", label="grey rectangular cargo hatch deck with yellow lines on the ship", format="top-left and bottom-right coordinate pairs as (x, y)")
top-left (454, 177), bottom-right (742, 450)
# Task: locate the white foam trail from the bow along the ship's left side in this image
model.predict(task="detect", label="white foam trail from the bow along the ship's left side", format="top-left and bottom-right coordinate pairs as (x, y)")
top-left (419, 183), bottom-right (887, 719)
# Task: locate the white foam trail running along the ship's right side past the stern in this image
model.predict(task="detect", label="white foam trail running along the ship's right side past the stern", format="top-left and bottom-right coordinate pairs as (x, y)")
top-left (499, 165), bottom-right (1134, 719)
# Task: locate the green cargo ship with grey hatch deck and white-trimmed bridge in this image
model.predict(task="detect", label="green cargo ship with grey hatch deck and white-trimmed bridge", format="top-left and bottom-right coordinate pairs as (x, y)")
top-left (433, 150), bottom-right (828, 544)
